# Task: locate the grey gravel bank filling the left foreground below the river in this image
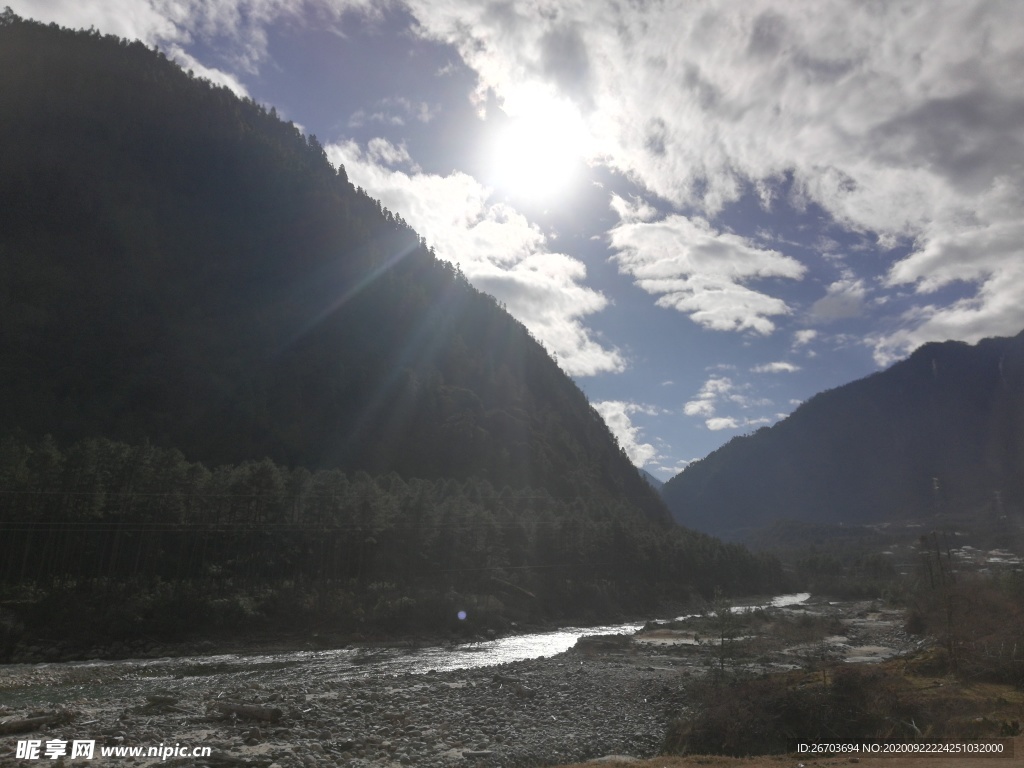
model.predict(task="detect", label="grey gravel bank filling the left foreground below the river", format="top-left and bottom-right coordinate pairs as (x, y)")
top-left (0, 651), bottom-right (684, 768)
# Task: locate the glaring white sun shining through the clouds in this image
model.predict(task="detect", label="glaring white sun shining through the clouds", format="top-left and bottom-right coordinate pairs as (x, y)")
top-left (488, 98), bottom-right (588, 203)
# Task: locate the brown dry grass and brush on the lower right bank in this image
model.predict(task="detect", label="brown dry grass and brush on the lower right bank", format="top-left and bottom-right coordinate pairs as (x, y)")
top-left (562, 581), bottom-right (1024, 768)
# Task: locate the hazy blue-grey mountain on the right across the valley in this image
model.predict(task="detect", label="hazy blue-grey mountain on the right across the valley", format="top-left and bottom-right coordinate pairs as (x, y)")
top-left (663, 333), bottom-right (1024, 538)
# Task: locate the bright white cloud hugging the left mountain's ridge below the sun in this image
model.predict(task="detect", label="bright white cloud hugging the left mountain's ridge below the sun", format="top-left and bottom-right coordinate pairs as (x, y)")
top-left (325, 139), bottom-right (626, 376)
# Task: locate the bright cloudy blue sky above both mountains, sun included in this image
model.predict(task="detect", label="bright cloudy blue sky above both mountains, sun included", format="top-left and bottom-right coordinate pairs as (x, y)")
top-left (14, 0), bottom-right (1024, 479)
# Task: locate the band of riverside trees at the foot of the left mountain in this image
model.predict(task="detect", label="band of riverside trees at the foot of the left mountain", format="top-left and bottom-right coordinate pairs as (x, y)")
top-left (0, 435), bottom-right (784, 651)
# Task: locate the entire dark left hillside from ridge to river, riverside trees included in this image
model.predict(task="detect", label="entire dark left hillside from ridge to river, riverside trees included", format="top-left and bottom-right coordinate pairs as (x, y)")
top-left (0, 11), bottom-right (798, 662)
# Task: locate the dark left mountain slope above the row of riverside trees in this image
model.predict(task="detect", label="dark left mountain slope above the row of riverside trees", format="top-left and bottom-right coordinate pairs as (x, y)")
top-left (0, 9), bottom-right (669, 521)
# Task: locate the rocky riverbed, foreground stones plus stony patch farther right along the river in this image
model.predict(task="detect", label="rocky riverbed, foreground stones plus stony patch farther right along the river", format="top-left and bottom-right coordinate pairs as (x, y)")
top-left (0, 603), bottom-right (916, 768)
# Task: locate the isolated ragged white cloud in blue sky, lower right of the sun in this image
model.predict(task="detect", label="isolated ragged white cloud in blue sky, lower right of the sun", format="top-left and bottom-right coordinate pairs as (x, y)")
top-left (608, 207), bottom-right (805, 335)
